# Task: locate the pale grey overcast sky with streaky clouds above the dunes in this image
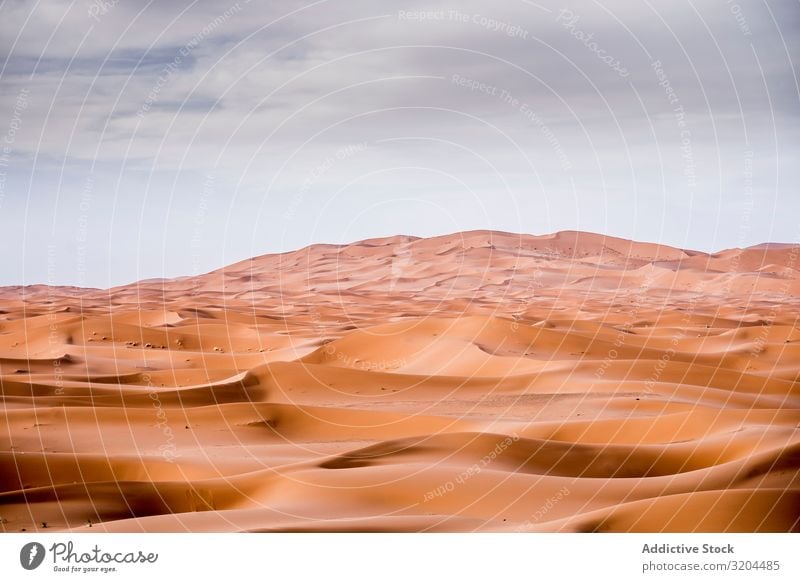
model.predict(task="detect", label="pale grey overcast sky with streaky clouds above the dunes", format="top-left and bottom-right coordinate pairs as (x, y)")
top-left (0, 0), bottom-right (800, 287)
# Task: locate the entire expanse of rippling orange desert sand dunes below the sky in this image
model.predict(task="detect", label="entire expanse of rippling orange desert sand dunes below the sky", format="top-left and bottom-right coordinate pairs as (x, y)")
top-left (0, 231), bottom-right (800, 532)
